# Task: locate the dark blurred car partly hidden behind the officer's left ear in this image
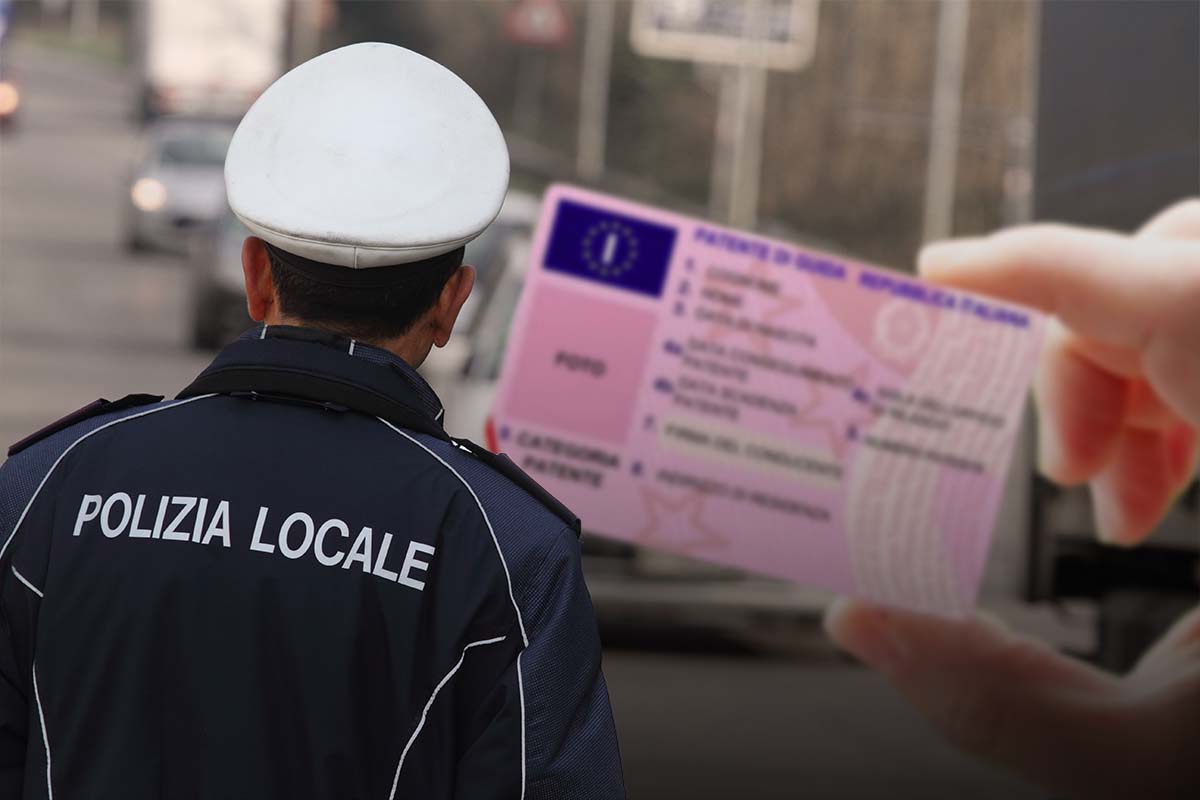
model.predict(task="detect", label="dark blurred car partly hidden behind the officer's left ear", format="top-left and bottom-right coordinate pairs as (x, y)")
top-left (188, 210), bottom-right (253, 350)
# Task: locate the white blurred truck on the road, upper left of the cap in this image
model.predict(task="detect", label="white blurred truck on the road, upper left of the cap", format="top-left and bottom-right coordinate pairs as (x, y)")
top-left (133, 0), bottom-right (288, 121)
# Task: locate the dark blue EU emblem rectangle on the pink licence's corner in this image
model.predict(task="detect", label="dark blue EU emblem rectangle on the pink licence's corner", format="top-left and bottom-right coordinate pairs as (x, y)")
top-left (546, 200), bottom-right (676, 297)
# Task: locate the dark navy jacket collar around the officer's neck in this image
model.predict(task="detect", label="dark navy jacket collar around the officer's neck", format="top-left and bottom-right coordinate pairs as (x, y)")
top-left (200, 325), bottom-right (445, 426)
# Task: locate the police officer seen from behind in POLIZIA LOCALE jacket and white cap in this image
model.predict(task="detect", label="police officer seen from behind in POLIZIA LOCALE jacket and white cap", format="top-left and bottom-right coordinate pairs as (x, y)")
top-left (0, 43), bottom-right (624, 800)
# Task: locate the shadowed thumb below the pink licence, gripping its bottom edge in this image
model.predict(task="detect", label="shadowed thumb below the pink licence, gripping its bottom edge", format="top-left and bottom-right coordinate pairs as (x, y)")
top-left (826, 600), bottom-right (1136, 798)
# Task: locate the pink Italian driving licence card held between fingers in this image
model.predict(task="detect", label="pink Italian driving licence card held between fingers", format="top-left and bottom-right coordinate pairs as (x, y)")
top-left (493, 186), bottom-right (1043, 614)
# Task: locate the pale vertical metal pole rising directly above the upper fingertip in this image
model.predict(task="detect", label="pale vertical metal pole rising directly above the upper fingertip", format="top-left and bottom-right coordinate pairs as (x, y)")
top-left (922, 0), bottom-right (971, 241)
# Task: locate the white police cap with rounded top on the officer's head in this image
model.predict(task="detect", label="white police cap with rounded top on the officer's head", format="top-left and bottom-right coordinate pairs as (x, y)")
top-left (224, 42), bottom-right (509, 269)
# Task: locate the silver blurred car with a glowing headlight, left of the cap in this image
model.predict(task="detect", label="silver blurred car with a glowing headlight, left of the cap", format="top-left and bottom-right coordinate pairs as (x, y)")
top-left (125, 119), bottom-right (234, 252)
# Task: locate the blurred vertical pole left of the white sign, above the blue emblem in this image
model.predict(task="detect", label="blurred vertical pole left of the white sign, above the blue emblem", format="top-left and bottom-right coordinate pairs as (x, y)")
top-left (575, 0), bottom-right (616, 180)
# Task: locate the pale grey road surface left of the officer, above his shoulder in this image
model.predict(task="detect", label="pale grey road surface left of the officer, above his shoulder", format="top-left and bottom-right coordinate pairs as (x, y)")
top-left (0, 40), bottom-right (206, 443)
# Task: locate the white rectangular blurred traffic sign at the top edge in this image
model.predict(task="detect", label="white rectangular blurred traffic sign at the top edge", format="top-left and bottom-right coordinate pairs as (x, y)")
top-left (630, 0), bottom-right (817, 70)
